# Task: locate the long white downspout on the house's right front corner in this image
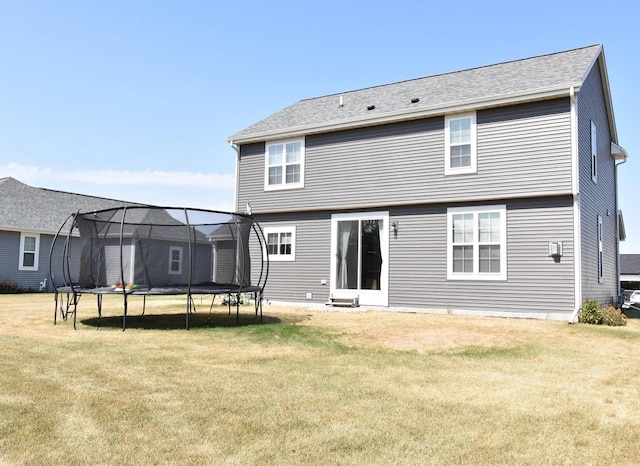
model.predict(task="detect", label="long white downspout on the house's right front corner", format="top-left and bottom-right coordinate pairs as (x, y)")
top-left (569, 86), bottom-right (582, 324)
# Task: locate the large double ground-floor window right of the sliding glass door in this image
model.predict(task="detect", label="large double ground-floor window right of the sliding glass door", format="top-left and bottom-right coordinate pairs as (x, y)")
top-left (447, 205), bottom-right (507, 280)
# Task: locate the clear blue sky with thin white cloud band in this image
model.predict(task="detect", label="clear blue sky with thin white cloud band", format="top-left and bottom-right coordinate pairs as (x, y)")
top-left (0, 0), bottom-right (640, 253)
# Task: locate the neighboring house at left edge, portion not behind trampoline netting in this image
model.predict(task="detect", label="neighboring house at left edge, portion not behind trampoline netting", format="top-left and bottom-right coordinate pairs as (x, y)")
top-left (0, 177), bottom-right (133, 290)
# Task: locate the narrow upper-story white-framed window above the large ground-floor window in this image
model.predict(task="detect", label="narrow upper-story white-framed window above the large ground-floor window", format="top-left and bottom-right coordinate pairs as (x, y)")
top-left (444, 112), bottom-right (477, 175)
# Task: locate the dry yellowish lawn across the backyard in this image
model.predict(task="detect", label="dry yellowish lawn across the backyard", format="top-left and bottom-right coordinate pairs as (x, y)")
top-left (0, 294), bottom-right (640, 465)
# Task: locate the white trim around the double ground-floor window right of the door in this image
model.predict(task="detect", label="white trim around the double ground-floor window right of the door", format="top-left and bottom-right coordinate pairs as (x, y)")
top-left (447, 205), bottom-right (507, 281)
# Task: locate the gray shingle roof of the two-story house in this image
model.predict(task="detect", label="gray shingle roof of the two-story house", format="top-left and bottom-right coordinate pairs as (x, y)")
top-left (228, 45), bottom-right (602, 142)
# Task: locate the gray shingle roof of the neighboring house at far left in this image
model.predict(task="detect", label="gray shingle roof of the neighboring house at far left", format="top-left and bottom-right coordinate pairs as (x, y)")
top-left (0, 177), bottom-right (139, 233)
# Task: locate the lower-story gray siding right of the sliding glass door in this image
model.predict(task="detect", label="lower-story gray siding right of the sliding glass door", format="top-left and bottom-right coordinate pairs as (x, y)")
top-left (389, 197), bottom-right (574, 317)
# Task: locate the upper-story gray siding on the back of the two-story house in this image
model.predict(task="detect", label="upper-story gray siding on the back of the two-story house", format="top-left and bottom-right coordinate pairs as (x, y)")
top-left (238, 99), bottom-right (571, 213)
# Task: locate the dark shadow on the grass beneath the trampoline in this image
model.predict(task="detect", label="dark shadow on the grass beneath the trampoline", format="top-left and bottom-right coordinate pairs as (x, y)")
top-left (80, 313), bottom-right (282, 330)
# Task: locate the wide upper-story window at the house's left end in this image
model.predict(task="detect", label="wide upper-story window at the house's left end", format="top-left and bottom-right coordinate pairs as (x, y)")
top-left (264, 139), bottom-right (304, 190)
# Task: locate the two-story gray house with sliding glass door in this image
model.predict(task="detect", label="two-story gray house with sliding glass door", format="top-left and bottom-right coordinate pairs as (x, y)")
top-left (229, 45), bottom-right (627, 321)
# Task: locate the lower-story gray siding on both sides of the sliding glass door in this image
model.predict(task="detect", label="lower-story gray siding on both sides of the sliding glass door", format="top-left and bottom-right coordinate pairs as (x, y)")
top-left (250, 196), bottom-right (575, 317)
